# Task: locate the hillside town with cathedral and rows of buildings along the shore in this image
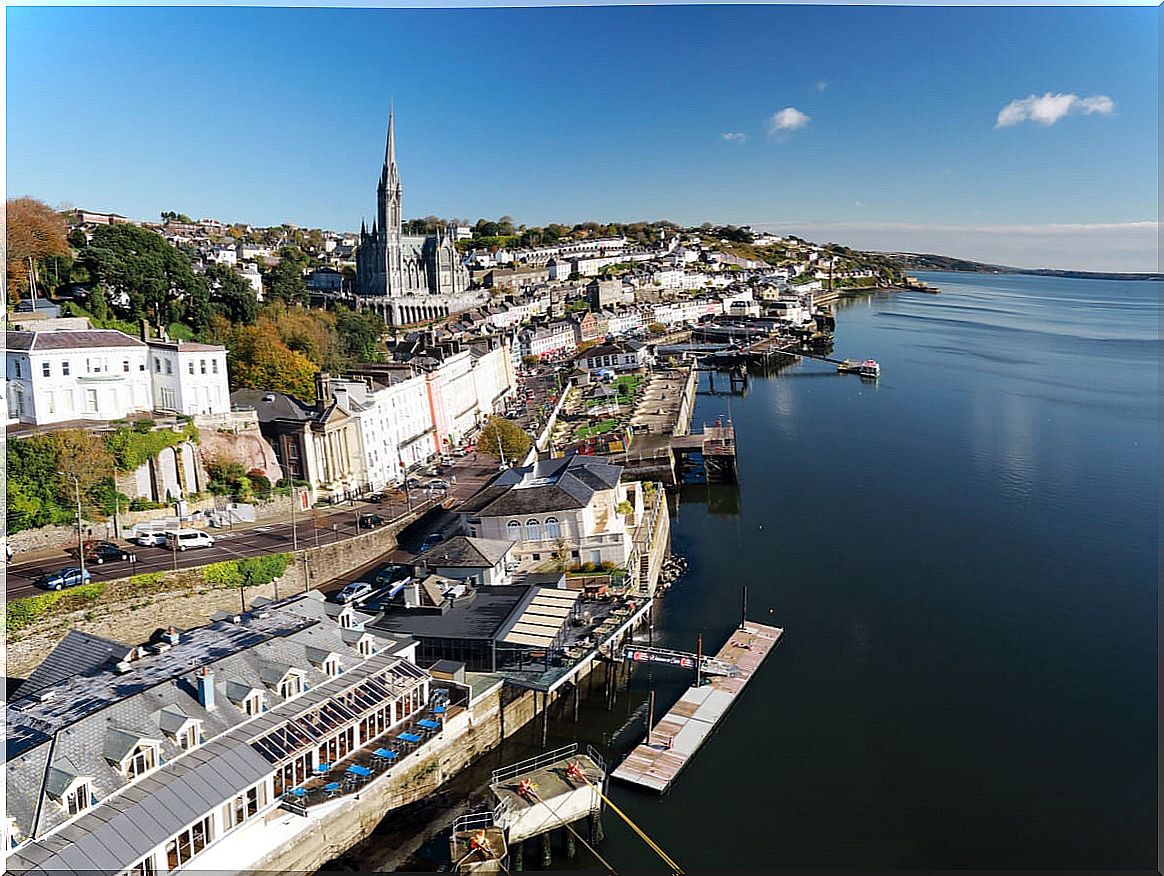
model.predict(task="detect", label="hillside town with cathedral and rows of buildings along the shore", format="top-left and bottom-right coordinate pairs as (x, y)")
top-left (5, 121), bottom-right (907, 876)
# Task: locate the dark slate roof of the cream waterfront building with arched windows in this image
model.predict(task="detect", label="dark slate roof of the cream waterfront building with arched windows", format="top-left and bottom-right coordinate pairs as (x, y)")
top-left (459, 455), bottom-right (623, 517)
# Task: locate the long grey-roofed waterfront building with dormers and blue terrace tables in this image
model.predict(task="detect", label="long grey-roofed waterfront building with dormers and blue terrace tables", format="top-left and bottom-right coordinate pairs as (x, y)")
top-left (3, 592), bottom-right (430, 876)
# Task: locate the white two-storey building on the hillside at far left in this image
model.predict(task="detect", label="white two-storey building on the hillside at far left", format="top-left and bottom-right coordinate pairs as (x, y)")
top-left (5, 321), bottom-right (230, 426)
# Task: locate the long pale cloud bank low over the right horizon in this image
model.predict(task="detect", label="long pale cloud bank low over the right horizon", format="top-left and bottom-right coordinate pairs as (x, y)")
top-left (748, 220), bottom-right (1161, 273)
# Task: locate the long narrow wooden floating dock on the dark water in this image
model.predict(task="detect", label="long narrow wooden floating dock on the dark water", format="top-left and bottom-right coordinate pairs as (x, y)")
top-left (610, 621), bottom-right (785, 793)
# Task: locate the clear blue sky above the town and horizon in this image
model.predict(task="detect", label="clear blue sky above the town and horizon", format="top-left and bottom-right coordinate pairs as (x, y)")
top-left (7, 6), bottom-right (1158, 270)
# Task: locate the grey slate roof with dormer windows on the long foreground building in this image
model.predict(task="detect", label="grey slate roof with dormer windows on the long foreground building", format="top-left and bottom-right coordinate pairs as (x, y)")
top-left (5, 591), bottom-right (410, 846)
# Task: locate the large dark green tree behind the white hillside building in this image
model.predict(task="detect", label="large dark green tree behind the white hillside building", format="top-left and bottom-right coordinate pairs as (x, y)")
top-left (78, 225), bottom-right (204, 326)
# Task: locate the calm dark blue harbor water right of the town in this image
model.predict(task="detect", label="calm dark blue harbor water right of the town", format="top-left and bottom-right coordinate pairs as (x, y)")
top-left (540, 273), bottom-right (1159, 870)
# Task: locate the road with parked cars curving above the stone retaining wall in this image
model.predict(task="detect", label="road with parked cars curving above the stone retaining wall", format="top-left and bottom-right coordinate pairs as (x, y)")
top-left (5, 455), bottom-right (497, 599)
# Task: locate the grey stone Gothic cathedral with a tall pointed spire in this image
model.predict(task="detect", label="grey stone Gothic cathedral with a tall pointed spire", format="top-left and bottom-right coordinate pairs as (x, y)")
top-left (356, 113), bottom-right (484, 326)
